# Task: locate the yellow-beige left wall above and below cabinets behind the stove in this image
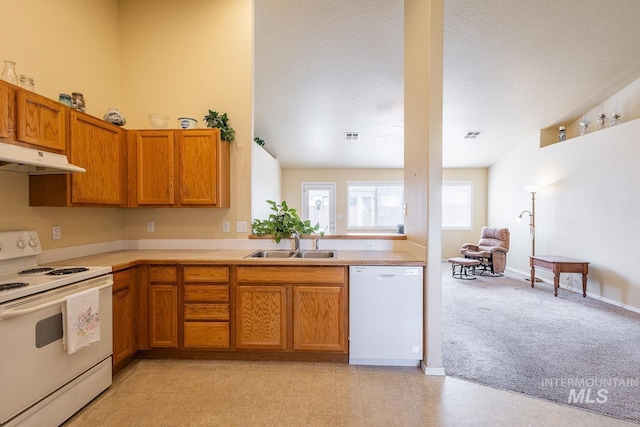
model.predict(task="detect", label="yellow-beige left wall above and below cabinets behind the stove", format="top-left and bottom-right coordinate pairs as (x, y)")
top-left (0, 0), bottom-right (123, 249)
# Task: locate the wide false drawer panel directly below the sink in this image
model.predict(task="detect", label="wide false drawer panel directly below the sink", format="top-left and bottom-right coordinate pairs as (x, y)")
top-left (237, 266), bottom-right (345, 284)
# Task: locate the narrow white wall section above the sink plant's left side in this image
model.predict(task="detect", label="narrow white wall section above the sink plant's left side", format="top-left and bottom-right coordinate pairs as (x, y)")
top-left (251, 144), bottom-right (282, 220)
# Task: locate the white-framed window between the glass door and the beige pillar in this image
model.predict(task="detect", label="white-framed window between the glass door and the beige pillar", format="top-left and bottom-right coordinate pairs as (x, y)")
top-left (347, 181), bottom-right (404, 230)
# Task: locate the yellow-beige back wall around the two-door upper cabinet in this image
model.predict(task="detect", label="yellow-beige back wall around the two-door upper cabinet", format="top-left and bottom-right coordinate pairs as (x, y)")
top-left (119, 0), bottom-right (255, 239)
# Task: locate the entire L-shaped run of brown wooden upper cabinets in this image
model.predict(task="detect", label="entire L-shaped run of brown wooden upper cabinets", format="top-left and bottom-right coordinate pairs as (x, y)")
top-left (0, 81), bottom-right (231, 208)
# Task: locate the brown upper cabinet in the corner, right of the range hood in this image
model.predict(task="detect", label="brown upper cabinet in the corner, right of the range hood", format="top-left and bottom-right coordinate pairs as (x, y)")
top-left (29, 110), bottom-right (127, 206)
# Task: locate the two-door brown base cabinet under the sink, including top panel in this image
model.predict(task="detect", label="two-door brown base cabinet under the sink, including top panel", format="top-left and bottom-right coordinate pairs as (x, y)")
top-left (235, 266), bottom-right (347, 354)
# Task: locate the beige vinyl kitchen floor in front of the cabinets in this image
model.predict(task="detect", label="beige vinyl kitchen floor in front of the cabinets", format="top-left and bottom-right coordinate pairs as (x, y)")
top-left (65, 360), bottom-right (635, 427)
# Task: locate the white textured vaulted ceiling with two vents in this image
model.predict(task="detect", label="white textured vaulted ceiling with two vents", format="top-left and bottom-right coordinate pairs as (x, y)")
top-left (254, 0), bottom-right (640, 168)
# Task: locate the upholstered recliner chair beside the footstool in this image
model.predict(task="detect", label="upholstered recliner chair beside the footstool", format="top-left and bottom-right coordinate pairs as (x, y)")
top-left (460, 227), bottom-right (510, 276)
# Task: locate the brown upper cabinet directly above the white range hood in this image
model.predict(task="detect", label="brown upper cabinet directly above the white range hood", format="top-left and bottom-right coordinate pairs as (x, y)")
top-left (0, 82), bottom-right (66, 153)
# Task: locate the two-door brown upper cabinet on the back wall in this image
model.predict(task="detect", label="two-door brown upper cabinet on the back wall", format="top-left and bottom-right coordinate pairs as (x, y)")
top-left (128, 129), bottom-right (230, 208)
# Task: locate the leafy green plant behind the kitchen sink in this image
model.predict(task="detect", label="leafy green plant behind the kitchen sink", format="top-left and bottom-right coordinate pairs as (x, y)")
top-left (251, 200), bottom-right (324, 243)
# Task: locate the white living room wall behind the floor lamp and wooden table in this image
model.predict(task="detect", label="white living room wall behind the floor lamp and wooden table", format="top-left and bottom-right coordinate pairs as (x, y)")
top-left (488, 119), bottom-right (640, 308)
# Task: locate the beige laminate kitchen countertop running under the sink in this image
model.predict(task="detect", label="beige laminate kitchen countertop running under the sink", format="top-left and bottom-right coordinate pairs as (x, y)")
top-left (51, 249), bottom-right (426, 271)
